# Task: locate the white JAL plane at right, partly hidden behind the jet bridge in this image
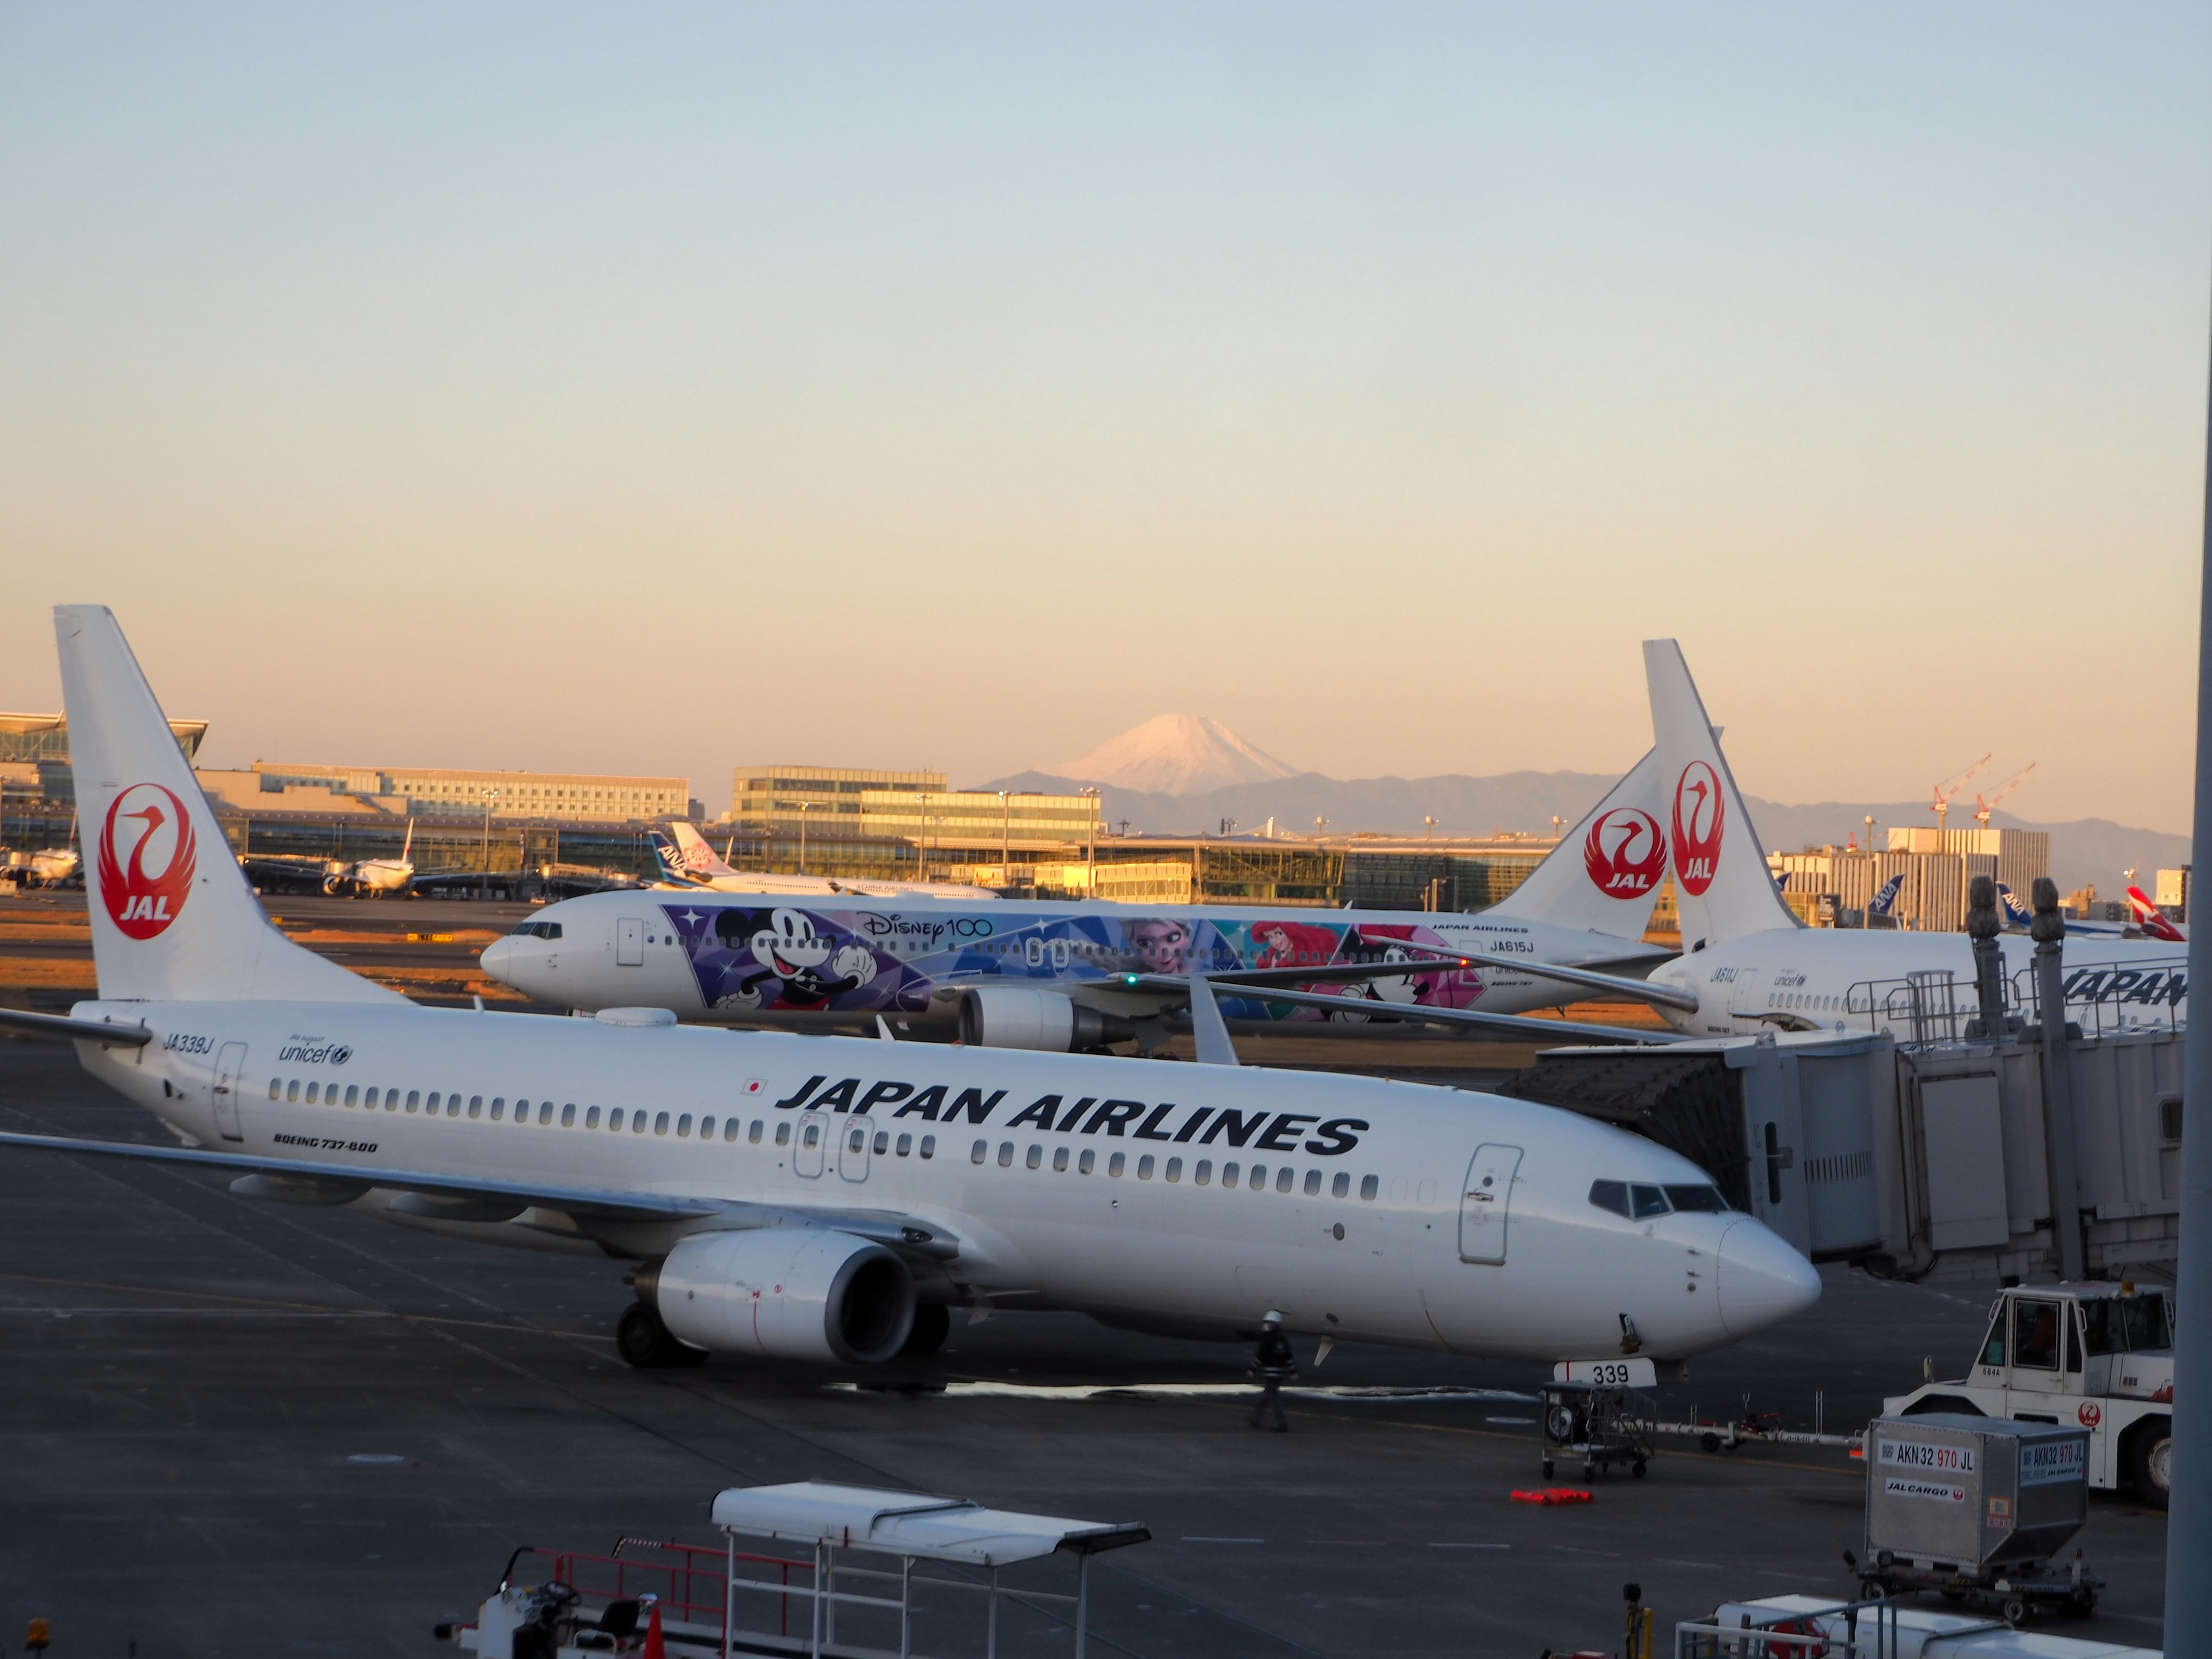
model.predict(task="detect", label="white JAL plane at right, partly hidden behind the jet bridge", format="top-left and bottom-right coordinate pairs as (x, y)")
top-left (1643, 639), bottom-right (2188, 1035)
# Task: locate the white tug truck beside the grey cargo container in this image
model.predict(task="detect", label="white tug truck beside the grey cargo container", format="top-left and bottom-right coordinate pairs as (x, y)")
top-left (1883, 1283), bottom-right (2175, 1509)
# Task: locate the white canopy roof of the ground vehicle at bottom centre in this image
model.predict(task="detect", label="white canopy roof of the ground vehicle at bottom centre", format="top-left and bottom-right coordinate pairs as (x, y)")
top-left (714, 1480), bottom-right (1153, 1566)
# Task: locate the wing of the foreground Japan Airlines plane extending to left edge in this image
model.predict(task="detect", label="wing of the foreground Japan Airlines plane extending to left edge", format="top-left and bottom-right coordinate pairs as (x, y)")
top-left (0, 1132), bottom-right (960, 1256)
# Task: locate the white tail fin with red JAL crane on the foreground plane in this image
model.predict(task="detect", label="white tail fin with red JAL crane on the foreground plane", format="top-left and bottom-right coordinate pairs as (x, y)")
top-left (53, 604), bottom-right (400, 1002)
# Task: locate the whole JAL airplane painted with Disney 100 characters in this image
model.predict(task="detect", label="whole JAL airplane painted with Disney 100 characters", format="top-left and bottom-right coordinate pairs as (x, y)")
top-left (482, 754), bottom-right (1696, 1051)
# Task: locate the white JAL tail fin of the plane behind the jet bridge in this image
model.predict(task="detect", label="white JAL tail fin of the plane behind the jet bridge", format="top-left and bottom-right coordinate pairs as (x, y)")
top-left (1643, 639), bottom-right (1803, 953)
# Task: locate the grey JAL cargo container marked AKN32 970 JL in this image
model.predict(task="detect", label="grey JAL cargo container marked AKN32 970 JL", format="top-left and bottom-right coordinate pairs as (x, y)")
top-left (1867, 1414), bottom-right (2088, 1577)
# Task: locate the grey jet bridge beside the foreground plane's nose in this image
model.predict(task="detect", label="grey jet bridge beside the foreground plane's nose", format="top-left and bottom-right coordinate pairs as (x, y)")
top-left (1502, 1024), bottom-right (2183, 1279)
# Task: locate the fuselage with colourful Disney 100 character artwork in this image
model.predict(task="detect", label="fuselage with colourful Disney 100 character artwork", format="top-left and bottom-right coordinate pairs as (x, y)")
top-left (482, 893), bottom-right (1654, 1022)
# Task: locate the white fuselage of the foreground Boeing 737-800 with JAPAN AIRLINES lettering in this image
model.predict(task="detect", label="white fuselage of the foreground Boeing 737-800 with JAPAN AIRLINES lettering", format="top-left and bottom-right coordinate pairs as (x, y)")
top-left (75, 1002), bottom-right (1818, 1361)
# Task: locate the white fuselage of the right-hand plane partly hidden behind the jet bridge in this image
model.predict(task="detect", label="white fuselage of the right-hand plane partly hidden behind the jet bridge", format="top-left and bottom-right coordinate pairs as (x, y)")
top-left (1650, 927), bottom-right (2188, 1035)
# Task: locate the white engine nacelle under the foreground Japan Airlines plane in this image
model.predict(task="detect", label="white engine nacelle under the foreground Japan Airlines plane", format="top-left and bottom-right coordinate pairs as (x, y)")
top-left (637, 1228), bottom-right (914, 1365)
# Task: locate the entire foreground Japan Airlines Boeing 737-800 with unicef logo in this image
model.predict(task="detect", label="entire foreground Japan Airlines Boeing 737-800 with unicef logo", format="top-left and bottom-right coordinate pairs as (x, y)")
top-left (0, 606), bottom-right (1818, 1365)
